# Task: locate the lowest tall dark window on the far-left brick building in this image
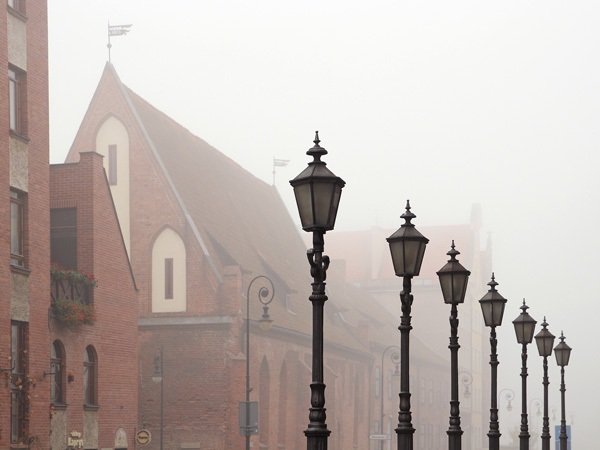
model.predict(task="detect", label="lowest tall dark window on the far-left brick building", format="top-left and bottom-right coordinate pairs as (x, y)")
top-left (10, 322), bottom-right (29, 444)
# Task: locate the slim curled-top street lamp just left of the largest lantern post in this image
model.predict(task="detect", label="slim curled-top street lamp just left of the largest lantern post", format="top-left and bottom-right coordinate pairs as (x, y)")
top-left (242, 275), bottom-right (275, 450)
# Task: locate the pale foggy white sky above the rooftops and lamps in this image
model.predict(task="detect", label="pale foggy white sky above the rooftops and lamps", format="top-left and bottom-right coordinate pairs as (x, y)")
top-left (48, 0), bottom-right (600, 449)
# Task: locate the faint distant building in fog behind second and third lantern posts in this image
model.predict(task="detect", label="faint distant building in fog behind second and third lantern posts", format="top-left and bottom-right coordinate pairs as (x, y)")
top-left (327, 205), bottom-right (492, 450)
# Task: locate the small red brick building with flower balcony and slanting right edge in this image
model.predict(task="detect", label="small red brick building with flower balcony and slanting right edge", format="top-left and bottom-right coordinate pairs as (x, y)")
top-left (46, 152), bottom-right (138, 450)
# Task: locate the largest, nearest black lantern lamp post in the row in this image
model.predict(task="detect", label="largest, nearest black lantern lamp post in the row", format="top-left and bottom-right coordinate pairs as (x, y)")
top-left (290, 131), bottom-right (346, 450)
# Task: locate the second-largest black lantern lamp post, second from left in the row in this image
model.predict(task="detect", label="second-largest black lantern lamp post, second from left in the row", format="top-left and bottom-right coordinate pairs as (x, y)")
top-left (387, 200), bottom-right (429, 450)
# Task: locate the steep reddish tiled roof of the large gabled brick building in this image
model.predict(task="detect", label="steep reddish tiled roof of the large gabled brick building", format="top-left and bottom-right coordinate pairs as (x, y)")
top-left (69, 63), bottom-right (446, 353)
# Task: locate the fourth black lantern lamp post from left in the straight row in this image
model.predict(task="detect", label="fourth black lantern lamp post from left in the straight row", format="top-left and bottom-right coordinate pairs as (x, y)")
top-left (479, 273), bottom-right (507, 450)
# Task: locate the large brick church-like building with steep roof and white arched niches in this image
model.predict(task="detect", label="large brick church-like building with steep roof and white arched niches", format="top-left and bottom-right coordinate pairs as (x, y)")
top-left (67, 64), bottom-right (432, 450)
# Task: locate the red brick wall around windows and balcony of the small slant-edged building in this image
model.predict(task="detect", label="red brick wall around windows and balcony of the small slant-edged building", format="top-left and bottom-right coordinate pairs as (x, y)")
top-left (50, 153), bottom-right (138, 448)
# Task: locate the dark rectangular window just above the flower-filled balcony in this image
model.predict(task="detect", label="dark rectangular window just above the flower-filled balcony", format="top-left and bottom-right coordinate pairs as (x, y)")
top-left (50, 208), bottom-right (77, 269)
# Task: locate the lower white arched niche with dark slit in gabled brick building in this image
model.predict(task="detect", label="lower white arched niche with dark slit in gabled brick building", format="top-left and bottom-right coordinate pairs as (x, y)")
top-left (152, 228), bottom-right (187, 312)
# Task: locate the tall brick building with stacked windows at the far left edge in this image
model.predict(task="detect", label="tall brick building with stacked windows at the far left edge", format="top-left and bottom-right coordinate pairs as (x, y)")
top-left (0, 0), bottom-right (50, 448)
